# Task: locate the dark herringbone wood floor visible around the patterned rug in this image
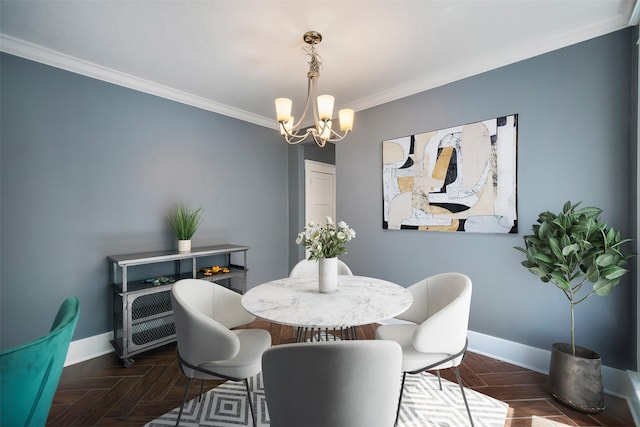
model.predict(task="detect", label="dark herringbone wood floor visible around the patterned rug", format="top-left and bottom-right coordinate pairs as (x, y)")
top-left (47, 320), bottom-right (633, 427)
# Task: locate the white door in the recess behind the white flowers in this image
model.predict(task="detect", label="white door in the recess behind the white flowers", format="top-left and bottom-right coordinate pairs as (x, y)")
top-left (304, 160), bottom-right (336, 225)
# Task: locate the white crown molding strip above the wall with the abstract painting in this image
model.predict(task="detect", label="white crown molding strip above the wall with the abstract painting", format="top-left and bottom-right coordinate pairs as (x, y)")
top-left (345, 13), bottom-right (640, 111)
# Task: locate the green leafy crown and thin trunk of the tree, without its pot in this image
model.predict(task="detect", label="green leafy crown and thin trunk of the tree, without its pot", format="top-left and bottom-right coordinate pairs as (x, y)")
top-left (515, 202), bottom-right (635, 355)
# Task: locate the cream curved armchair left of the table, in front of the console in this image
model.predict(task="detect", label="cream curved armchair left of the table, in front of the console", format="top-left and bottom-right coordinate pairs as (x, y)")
top-left (171, 279), bottom-right (271, 426)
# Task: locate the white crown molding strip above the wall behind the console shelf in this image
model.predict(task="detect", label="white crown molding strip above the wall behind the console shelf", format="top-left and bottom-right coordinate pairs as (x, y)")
top-left (0, 33), bottom-right (278, 129)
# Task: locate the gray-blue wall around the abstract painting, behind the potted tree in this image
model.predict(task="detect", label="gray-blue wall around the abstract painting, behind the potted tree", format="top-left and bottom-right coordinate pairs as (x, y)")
top-left (336, 30), bottom-right (637, 368)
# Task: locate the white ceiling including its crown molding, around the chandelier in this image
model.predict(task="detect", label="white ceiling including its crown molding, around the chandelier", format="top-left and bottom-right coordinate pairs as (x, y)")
top-left (0, 0), bottom-right (638, 128)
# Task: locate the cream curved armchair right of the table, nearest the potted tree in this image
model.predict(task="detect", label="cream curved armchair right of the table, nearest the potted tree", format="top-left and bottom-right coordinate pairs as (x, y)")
top-left (376, 273), bottom-right (473, 426)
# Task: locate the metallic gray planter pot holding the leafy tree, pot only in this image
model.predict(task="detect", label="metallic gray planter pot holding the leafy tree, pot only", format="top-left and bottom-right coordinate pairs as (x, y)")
top-left (549, 343), bottom-right (605, 413)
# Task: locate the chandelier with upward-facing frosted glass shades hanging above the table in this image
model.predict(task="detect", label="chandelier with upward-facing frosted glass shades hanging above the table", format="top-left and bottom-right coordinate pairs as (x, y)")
top-left (276, 31), bottom-right (353, 147)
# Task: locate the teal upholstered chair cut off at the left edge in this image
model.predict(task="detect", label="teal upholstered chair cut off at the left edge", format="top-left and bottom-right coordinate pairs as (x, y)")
top-left (0, 297), bottom-right (80, 427)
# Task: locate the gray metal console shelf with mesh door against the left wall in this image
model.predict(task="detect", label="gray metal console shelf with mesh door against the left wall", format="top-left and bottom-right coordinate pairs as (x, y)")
top-left (107, 245), bottom-right (249, 367)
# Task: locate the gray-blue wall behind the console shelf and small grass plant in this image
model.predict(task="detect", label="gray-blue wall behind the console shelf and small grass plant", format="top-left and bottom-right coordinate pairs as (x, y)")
top-left (0, 54), bottom-right (289, 348)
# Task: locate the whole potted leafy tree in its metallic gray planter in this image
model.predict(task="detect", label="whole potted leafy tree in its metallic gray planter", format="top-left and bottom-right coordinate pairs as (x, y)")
top-left (516, 202), bottom-right (635, 413)
